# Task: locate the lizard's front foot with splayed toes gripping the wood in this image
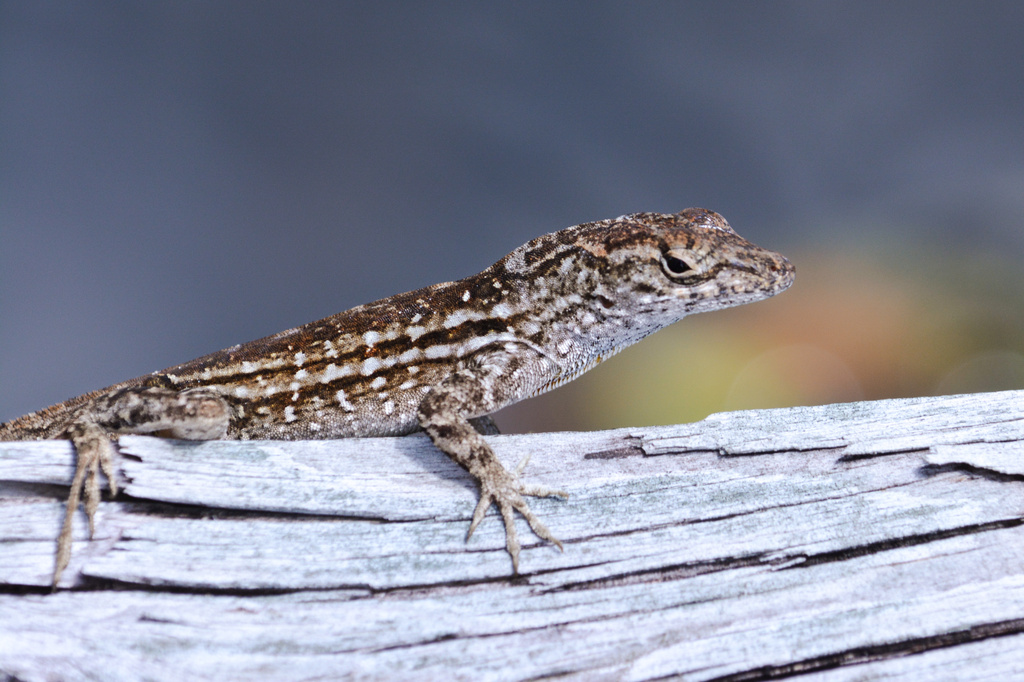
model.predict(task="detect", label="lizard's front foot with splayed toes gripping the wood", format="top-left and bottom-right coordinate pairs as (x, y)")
top-left (466, 455), bottom-right (569, 573)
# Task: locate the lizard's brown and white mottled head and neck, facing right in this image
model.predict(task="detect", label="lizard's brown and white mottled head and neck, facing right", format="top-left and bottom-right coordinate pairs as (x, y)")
top-left (491, 208), bottom-right (794, 356)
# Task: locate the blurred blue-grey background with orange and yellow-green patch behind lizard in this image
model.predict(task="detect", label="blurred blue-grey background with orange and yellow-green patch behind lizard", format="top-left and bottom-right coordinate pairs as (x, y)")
top-left (0, 1), bottom-right (1024, 430)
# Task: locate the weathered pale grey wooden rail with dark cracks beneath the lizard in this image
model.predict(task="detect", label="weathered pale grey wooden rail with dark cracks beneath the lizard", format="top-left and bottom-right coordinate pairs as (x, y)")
top-left (0, 391), bottom-right (1024, 680)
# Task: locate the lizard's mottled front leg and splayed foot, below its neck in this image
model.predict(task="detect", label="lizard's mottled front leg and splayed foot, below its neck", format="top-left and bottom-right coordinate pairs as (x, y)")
top-left (417, 342), bottom-right (568, 573)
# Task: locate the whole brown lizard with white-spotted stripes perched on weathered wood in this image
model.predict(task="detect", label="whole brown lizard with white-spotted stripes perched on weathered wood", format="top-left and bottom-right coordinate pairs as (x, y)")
top-left (0, 208), bottom-right (795, 588)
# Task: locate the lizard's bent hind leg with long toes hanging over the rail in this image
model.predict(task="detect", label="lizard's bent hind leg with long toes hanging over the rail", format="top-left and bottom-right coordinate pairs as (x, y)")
top-left (53, 386), bottom-right (230, 587)
